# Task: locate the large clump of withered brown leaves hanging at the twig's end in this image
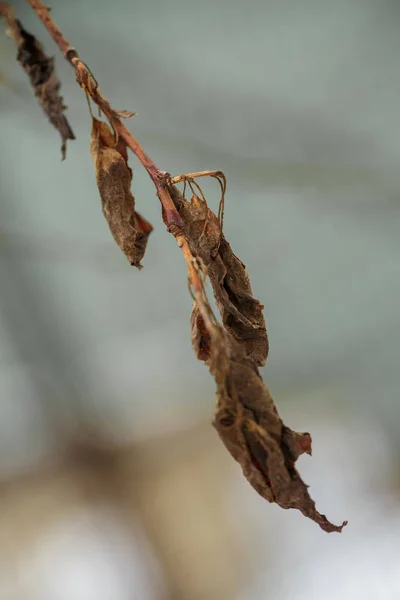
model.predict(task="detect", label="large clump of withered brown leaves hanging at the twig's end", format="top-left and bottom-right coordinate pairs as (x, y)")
top-left (171, 187), bottom-right (345, 532)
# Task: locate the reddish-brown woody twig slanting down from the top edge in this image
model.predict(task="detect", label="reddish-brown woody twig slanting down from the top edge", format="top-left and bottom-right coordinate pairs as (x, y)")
top-left (27, 0), bottom-right (183, 232)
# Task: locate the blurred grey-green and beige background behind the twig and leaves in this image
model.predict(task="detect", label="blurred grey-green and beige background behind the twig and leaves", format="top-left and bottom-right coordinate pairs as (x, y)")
top-left (0, 0), bottom-right (400, 600)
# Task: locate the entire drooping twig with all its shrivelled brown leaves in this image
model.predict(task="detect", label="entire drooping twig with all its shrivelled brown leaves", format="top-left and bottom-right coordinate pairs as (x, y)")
top-left (0, 0), bottom-right (346, 532)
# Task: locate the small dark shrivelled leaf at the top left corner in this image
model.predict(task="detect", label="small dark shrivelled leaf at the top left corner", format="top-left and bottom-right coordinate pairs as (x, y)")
top-left (13, 20), bottom-right (75, 159)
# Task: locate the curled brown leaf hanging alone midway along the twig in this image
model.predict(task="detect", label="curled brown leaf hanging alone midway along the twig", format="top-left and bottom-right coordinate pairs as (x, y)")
top-left (91, 119), bottom-right (153, 269)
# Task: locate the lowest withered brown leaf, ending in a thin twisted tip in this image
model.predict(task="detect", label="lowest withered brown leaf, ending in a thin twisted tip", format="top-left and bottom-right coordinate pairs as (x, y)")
top-left (191, 308), bottom-right (347, 532)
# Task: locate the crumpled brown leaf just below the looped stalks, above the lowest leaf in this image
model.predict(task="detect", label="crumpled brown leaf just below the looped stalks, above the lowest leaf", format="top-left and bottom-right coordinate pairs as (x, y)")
top-left (169, 186), bottom-right (268, 366)
